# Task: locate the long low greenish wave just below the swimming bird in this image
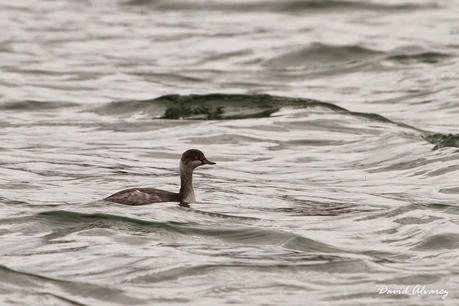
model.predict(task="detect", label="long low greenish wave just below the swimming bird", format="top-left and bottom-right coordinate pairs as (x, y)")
top-left (32, 210), bottom-right (351, 254)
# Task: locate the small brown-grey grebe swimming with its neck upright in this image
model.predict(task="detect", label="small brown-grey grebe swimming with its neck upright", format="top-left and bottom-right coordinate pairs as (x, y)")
top-left (104, 149), bottom-right (215, 205)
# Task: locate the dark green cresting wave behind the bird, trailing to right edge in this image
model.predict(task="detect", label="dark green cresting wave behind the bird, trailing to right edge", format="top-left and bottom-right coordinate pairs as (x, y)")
top-left (90, 94), bottom-right (459, 150)
